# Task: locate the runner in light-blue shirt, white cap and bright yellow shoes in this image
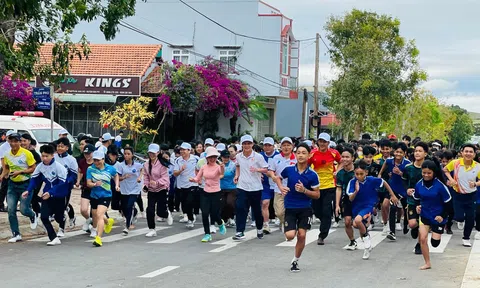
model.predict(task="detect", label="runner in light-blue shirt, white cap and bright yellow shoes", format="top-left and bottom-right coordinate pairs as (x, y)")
top-left (87, 150), bottom-right (120, 247)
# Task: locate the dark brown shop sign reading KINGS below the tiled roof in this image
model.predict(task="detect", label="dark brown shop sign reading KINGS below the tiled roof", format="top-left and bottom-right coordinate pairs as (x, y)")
top-left (35, 75), bottom-right (141, 96)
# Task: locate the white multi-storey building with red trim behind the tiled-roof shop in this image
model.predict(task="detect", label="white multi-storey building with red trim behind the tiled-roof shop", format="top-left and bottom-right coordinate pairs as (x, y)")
top-left (73, 0), bottom-right (299, 140)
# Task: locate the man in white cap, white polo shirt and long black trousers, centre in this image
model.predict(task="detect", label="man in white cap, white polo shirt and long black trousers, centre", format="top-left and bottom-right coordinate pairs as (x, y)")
top-left (233, 135), bottom-right (268, 240)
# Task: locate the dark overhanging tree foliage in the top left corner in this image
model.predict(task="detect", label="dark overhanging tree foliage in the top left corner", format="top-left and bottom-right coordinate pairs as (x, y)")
top-left (0, 0), bottom-right (136, 81)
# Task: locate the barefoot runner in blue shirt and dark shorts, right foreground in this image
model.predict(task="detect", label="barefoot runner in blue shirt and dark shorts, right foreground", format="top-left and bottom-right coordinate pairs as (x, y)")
top-left (409, 160), bottom-right (452, 270)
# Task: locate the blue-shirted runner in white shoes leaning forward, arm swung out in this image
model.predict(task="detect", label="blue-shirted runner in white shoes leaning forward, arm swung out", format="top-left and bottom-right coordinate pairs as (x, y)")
top-left (347, 160), bottom-right (398, 260)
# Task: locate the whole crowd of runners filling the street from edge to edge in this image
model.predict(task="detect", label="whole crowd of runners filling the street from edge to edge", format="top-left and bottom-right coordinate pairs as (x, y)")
top-left (0, 130), bottom-right (480, 272)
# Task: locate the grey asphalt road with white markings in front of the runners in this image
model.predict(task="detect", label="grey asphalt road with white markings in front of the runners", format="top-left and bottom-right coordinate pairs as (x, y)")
top-left (0, 217), bottom-right (480, 288)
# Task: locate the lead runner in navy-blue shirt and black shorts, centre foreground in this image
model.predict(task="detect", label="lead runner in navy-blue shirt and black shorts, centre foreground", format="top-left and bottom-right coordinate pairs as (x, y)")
top-left (275, 143), bottom-right (320, 272)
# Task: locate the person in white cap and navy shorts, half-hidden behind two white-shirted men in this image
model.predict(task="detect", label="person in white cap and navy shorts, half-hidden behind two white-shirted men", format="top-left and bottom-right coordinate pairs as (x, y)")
top-left (260, 137), bottom-right (279, 234)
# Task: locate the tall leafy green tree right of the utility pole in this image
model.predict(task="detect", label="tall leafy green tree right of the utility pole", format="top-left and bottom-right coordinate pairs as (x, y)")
top-left (325, 9), bottom-right (426, 138)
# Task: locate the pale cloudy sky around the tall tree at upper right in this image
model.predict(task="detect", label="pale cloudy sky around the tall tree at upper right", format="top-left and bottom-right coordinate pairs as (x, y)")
top-left (266, 0), bottom-right (480, 113)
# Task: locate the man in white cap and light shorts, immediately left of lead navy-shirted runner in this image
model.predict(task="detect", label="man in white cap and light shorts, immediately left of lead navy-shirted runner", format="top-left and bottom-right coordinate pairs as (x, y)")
top-left (263, 137), bottom-right (297, 231)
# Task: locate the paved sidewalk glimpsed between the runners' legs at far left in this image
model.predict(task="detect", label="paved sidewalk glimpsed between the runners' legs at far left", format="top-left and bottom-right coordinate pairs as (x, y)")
top-left (0, 189), bottom-right (137, 244)
